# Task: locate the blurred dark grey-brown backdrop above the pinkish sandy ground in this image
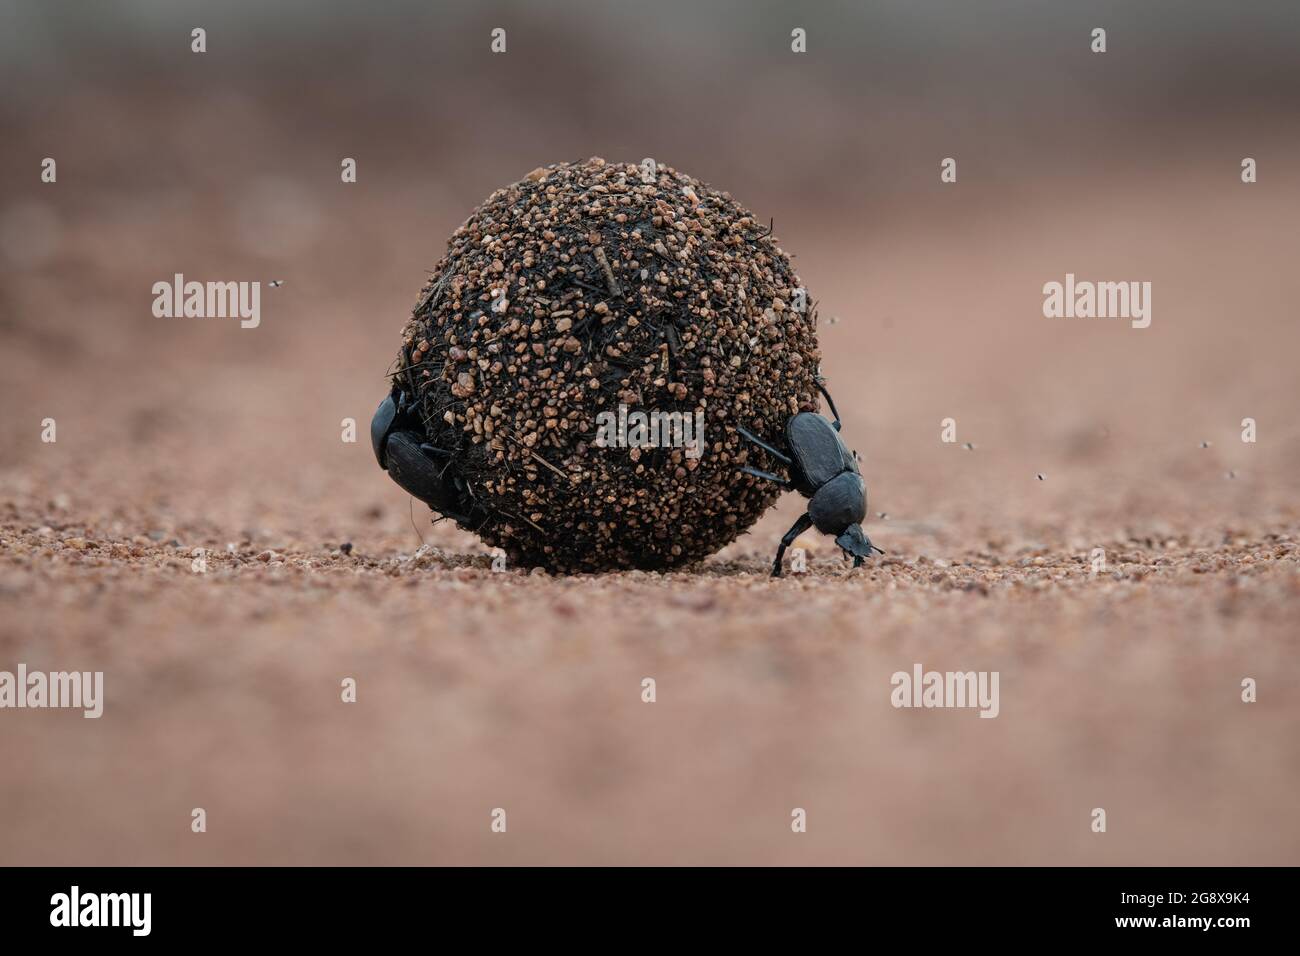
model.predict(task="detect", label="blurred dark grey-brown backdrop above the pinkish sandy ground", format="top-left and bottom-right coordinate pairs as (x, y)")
top-left (0, 0), bottom-right (1300, 215)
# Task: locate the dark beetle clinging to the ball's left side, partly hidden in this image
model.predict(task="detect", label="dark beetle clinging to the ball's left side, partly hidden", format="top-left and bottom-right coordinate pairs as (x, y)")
top-left (371, 385), bottom-right (488, 531)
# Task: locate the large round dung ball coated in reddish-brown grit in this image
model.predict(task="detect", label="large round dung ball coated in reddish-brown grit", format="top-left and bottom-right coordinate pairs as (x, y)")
top-left (394, 159), bottom-right (819, 572)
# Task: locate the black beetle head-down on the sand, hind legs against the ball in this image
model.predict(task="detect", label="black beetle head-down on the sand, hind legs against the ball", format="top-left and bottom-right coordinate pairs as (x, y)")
top-left (736, 380), bottom-right (884, 578)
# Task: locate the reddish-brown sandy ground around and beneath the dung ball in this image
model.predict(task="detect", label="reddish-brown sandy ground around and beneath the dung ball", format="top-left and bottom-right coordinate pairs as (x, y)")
top-left (0, 102), bottom-right (1300, 864)
